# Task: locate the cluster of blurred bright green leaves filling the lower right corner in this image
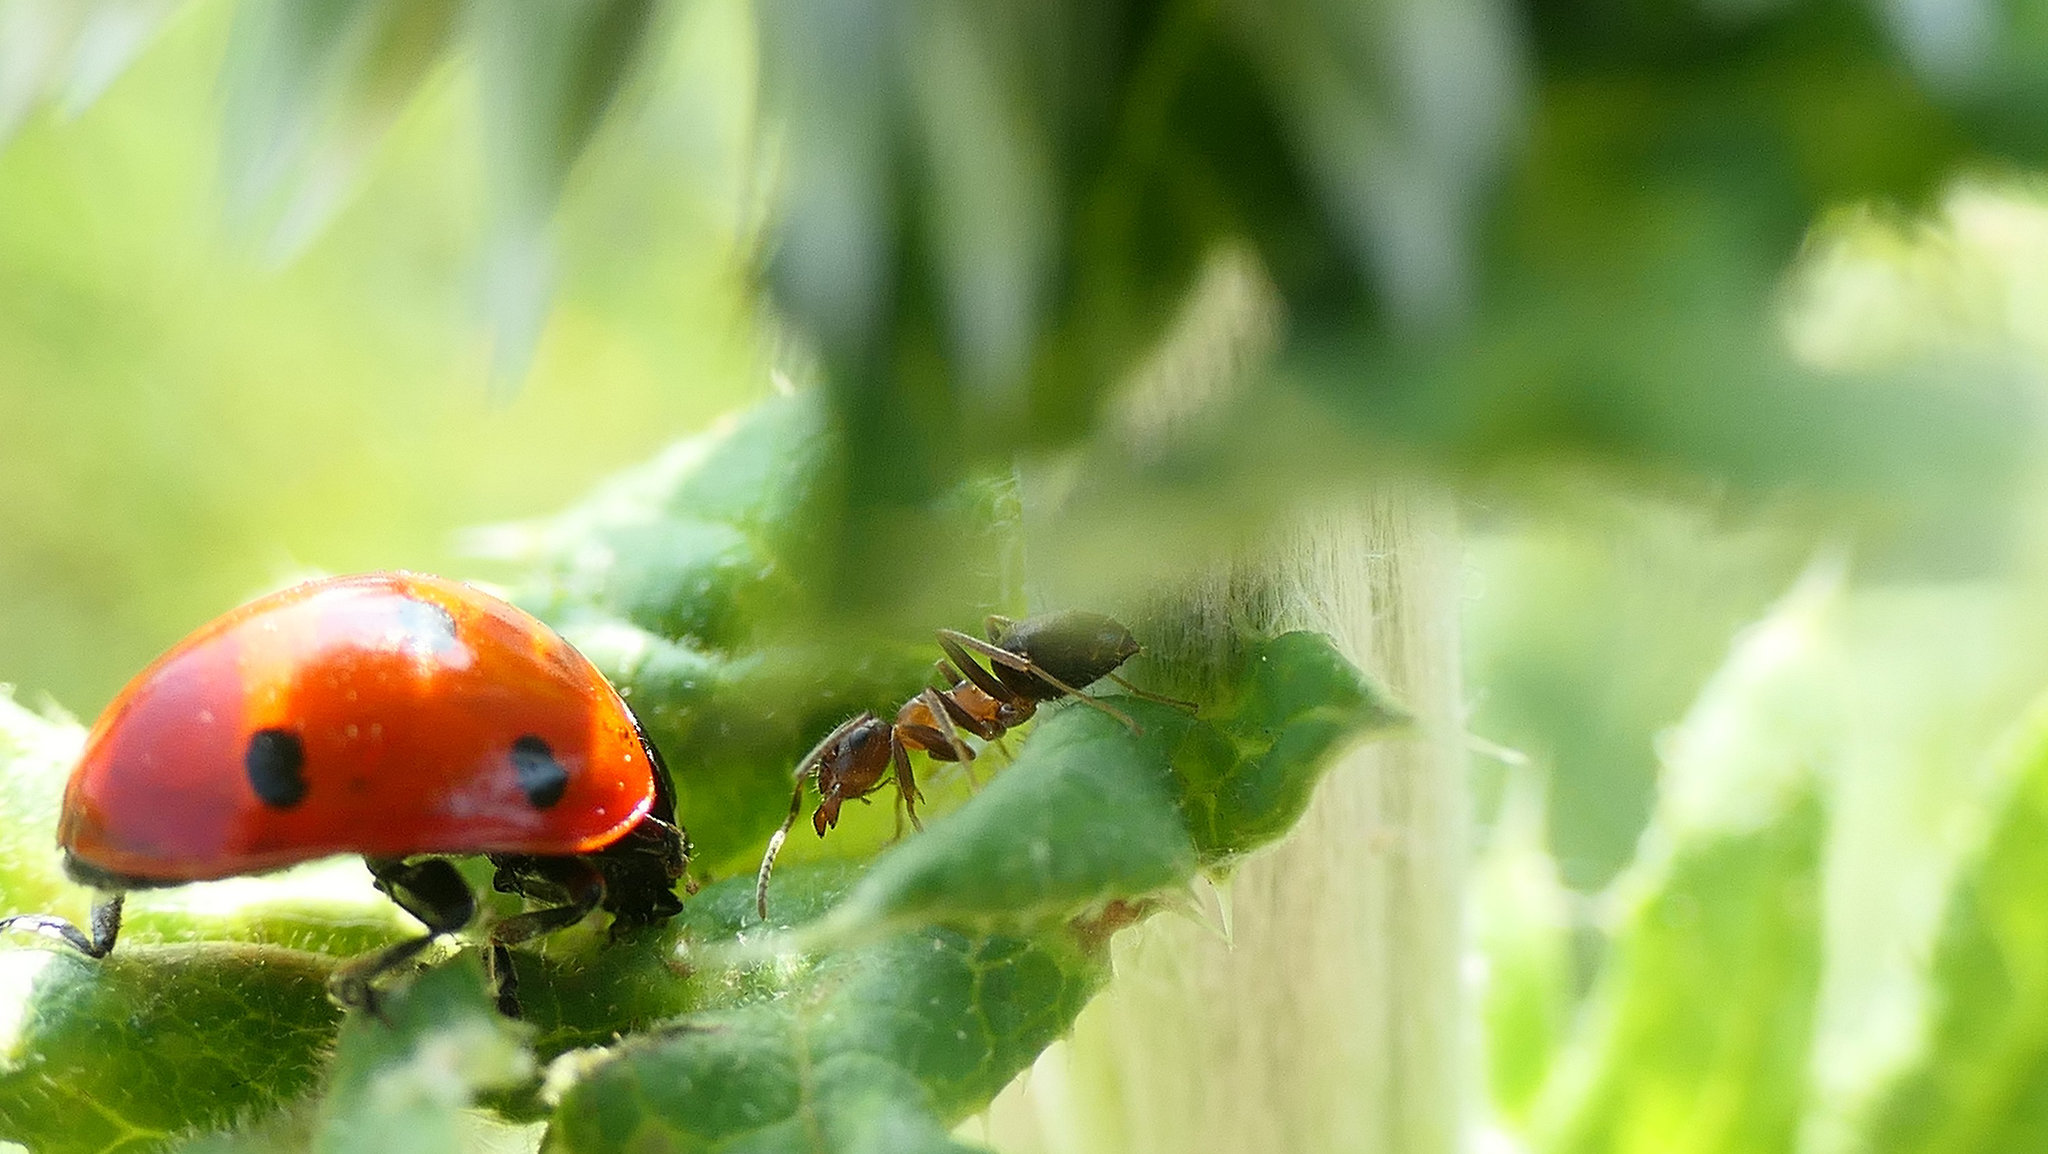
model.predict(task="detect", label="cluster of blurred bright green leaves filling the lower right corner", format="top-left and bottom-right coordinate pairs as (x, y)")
top-left (1479, 553), bottom-right (2048, 1154)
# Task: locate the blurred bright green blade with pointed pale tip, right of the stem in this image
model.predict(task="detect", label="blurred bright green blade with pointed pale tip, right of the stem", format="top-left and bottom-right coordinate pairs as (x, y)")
top-left (1530, 566), bottom-right (1839, 1154)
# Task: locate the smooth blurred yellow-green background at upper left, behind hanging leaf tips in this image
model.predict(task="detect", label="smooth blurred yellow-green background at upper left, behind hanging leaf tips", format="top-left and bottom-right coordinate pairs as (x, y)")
top-left (0, 0), bottom-right (768, 719)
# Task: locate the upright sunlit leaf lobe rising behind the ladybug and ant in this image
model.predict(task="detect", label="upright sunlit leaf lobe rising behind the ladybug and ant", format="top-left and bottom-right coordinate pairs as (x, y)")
top-left (471, 394), bottom-right (1016, 875)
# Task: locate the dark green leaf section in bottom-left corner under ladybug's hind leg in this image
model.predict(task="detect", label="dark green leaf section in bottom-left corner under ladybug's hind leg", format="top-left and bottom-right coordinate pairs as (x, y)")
top-left (0, 943), bottom-right (340, 1154)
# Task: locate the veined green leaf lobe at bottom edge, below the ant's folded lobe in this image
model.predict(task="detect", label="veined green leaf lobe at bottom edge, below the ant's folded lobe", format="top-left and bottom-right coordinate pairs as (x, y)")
top-left (549, 871), bottom-right (1102, 1154)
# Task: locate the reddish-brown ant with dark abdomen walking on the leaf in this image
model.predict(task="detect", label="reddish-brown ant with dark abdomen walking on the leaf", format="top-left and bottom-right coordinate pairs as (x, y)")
top-left (754, 609), bottom-right (1194, 920)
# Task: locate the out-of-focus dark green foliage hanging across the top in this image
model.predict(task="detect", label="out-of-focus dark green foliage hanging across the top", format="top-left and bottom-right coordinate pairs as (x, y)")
top-left (8, 0), bottom-right (2015, 619)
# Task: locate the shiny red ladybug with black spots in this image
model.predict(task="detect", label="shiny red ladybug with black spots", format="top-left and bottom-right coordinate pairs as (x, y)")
top-left (0, 572), bottom-right (690, 1017)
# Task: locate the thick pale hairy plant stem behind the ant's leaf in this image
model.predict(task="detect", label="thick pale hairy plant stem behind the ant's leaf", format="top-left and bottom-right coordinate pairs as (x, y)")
top-left (987, 494), bottom-right (1466, 1154)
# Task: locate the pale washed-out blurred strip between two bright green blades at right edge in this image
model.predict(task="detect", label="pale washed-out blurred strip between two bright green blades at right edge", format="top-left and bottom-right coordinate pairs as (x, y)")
top-left (1802, 582), bottom-right (2048, 1154)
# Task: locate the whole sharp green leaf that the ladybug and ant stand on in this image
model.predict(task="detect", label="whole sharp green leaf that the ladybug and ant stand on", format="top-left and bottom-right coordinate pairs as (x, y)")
top-left (0, 398), bottom-right (1401, 1154)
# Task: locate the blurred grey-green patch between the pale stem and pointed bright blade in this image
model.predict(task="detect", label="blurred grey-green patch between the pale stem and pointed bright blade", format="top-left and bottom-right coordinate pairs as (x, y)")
top-left (1464, 502), bottom-right (1810, 892)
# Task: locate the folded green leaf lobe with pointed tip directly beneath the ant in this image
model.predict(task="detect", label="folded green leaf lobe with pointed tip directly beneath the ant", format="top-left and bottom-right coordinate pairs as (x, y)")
top-left (799, 633), bottom-right (1403, 941)
